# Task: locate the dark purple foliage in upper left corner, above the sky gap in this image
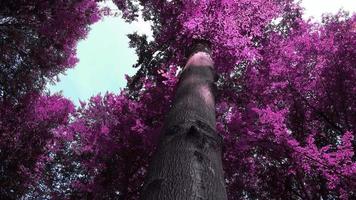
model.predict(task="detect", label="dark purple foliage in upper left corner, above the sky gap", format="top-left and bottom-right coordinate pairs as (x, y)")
top-left (0, 0), bottom-right (100, 101)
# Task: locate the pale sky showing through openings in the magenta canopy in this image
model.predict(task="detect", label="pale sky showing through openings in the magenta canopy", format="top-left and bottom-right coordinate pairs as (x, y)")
top-left (47, 0), bottom-right (356, 105)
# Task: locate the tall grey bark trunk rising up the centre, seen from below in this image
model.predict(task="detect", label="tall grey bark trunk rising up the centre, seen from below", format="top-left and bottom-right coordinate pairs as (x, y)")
top-left (142, 44), bottom-right (227, 200)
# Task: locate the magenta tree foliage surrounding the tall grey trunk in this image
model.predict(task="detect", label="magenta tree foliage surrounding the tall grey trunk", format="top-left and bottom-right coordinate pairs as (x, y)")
top-left (0, 0), bottom-right (356, 200)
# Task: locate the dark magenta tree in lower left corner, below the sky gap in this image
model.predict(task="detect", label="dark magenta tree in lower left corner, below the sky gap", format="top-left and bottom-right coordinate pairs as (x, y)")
top-left (0, 95), bottom-right (74, 199)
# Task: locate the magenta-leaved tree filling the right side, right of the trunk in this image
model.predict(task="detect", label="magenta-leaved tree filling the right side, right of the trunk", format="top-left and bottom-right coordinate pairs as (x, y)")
top-left (221, 13), bottom-right (355, 199)
